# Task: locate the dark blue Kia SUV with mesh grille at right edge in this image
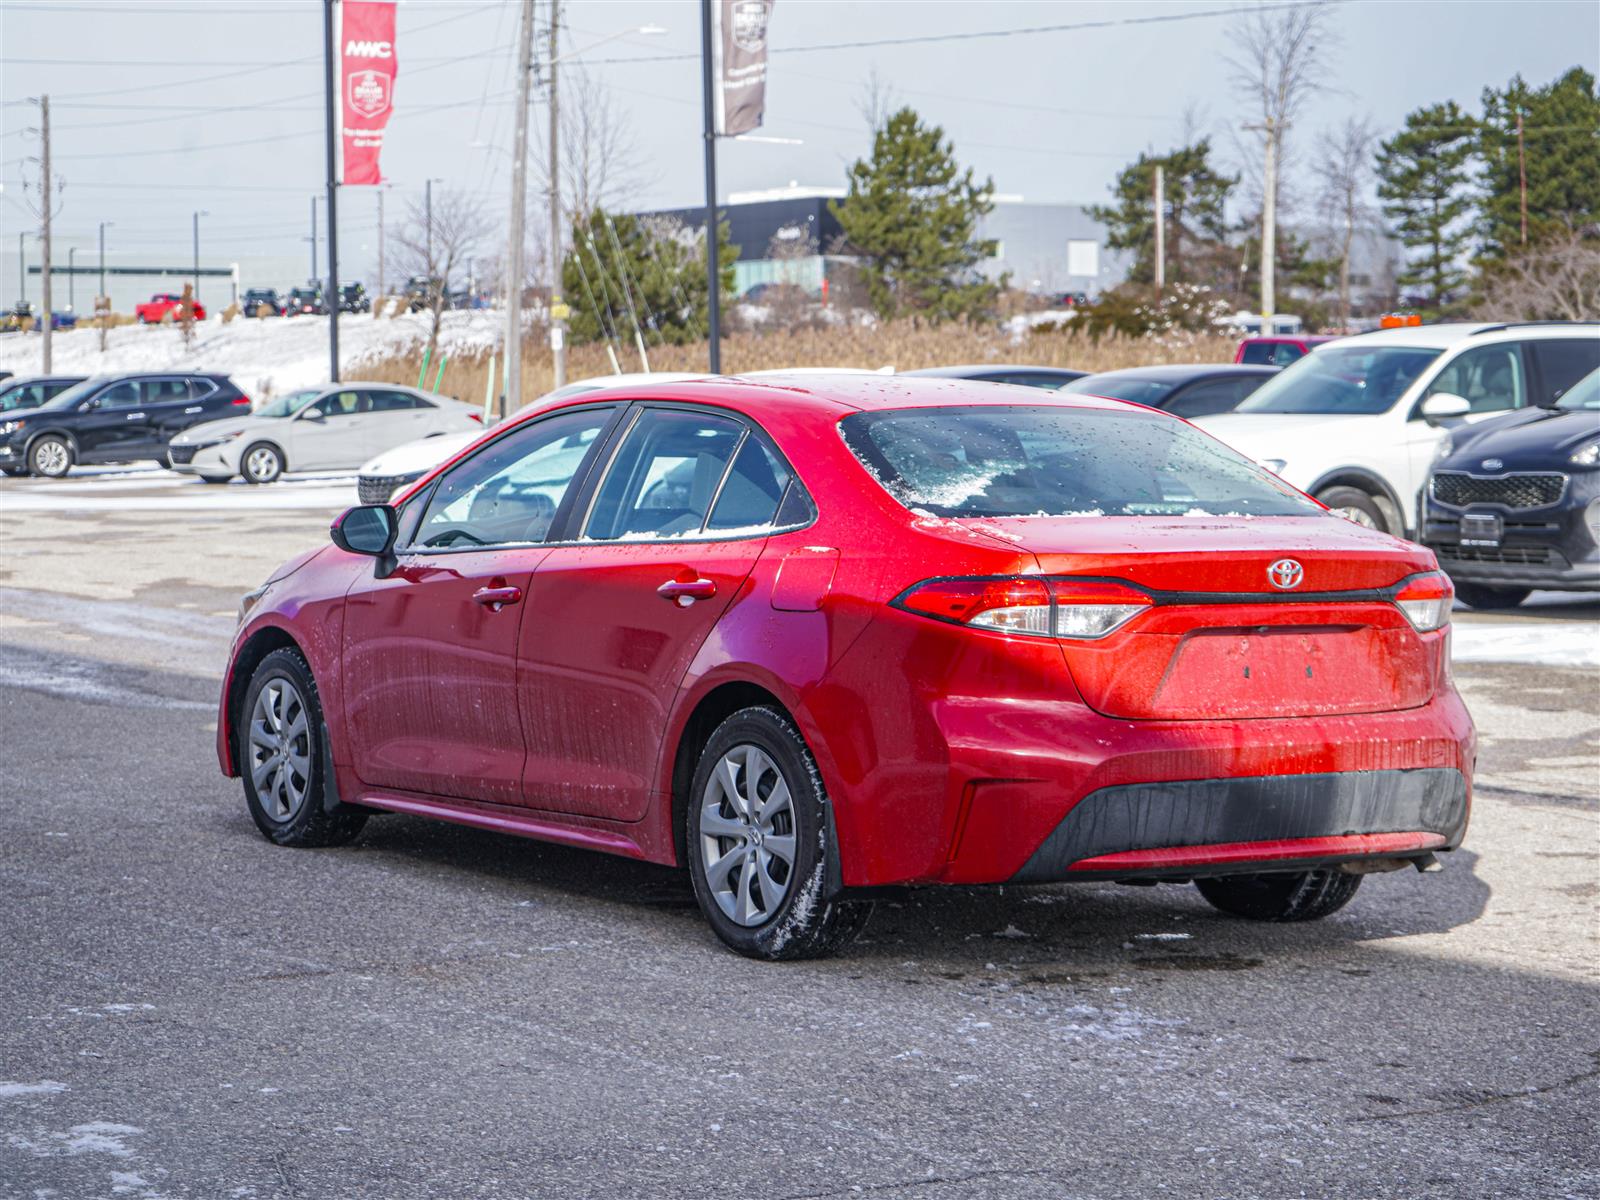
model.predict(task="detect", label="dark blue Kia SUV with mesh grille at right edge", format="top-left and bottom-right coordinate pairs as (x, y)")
top-left (1422, 371), bottom-right (1600, 608)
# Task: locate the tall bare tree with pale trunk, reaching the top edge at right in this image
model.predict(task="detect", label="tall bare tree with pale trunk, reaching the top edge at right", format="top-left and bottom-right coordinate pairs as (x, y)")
top-left (1227, 3), bottom-right (1334, 310)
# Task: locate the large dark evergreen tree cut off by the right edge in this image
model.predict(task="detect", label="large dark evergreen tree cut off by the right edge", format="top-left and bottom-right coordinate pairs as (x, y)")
top-left (1478, 67), bottom-right (1600, 258)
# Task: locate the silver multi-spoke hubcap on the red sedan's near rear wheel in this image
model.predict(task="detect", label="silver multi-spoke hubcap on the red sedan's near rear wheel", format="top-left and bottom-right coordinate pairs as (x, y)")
top-left (699, 744), bottom-right (795, 926)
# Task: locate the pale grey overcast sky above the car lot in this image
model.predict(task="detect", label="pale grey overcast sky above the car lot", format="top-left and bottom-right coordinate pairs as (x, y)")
top-left (0, 0), bottom-right (1600, 293)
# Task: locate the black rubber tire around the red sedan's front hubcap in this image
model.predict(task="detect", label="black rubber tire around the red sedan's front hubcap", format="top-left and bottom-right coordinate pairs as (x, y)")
top-left (237, 646), bottom-right (368, 846)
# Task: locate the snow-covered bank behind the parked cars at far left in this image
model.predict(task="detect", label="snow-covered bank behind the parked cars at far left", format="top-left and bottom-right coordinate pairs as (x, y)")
top-left (0, 309), bottom-right (501, 400)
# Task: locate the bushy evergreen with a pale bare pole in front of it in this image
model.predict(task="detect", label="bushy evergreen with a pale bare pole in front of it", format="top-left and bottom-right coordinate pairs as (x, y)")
top-left (1085, 138), bottom-right (1238, 283)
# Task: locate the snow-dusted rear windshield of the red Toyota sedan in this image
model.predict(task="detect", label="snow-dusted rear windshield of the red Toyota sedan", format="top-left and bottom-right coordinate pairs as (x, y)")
top-left (840, 405), bottom-right (1322, 517)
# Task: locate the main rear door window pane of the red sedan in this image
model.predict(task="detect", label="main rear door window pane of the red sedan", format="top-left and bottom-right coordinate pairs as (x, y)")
top-left (584, 408), bottom-right (744, 541)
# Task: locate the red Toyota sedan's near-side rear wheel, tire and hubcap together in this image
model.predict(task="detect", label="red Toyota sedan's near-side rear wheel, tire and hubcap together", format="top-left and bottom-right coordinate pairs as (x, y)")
top-left (685, 707), bottom-right (872, 960)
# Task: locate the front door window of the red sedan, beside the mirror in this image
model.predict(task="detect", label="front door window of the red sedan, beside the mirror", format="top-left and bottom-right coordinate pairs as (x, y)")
top-left (413, 408), bottom-right (614, 547)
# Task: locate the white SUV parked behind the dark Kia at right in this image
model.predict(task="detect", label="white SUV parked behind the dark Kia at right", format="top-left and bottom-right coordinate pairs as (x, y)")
top-left (1195, 323), bottom-right (1600, 536)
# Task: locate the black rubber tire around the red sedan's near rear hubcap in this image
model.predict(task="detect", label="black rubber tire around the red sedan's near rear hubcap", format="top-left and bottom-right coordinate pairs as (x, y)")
top-left (685, 707), bottom-right (872, 962)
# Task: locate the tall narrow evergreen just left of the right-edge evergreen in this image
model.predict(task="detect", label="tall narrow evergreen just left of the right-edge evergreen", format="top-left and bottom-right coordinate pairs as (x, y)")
top-left (1378, 101), bottom-right (1477, 315)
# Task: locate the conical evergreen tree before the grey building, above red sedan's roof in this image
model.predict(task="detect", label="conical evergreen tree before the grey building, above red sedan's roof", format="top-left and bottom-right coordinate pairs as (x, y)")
top-left (829, 107), bottom-right (1003, 322)
